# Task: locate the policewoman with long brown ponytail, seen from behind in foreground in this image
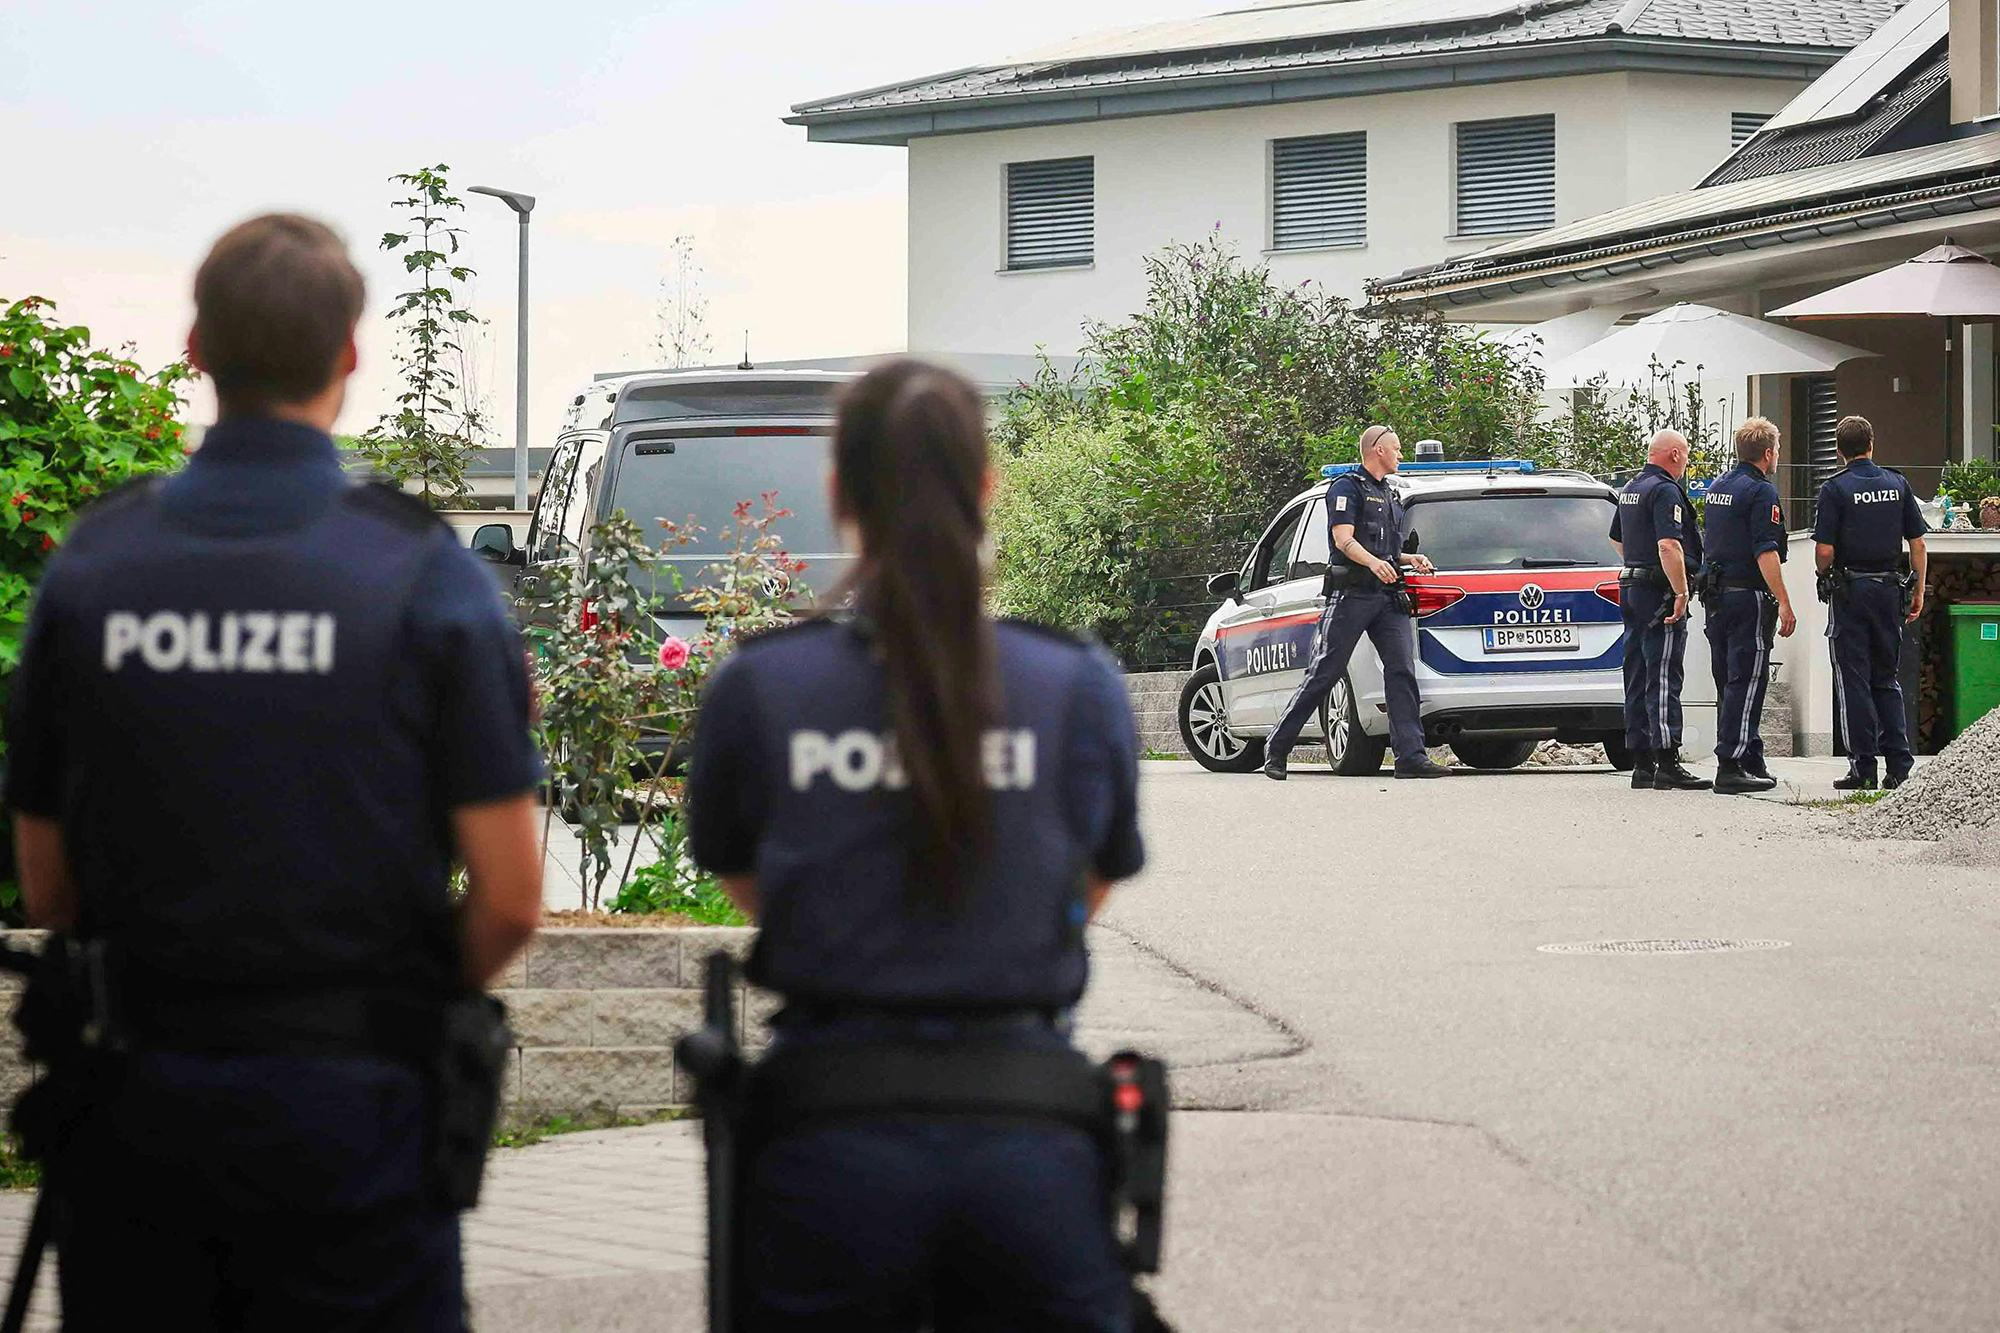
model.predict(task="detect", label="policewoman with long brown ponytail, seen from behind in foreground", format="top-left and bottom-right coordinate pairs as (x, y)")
top-left (688, 360), bottom-right (1144, 1333)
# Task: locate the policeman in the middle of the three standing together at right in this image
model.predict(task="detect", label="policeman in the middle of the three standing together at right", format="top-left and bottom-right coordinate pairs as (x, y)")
top-left (1702, 416), bottom-right (1798, 795)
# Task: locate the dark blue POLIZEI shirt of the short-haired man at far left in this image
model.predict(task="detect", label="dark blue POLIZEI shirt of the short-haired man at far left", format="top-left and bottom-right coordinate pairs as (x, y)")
top-left (6, 420), bottom-right (540, 991)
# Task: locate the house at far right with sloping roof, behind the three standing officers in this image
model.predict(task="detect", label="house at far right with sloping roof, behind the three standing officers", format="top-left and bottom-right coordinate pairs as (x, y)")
top-left (1368, 0), bottom-right (2000, 755)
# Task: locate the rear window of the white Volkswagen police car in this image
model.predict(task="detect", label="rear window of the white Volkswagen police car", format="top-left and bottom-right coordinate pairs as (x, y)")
top-left (1410, 492), bottom-right (1618, 570)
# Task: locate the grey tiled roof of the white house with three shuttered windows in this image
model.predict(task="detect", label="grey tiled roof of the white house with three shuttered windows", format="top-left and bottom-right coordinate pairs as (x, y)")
top-left (792, 0), bottom-right (1896, 124)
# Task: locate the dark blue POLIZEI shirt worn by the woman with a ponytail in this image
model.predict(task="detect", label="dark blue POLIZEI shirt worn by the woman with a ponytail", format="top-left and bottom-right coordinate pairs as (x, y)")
top-left (688, 620), bottom-right (1146, 1009)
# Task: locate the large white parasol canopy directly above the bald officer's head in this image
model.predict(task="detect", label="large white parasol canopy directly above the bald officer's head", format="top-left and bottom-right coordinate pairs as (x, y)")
top-left (1548, 304), bottom-right (1876, 388)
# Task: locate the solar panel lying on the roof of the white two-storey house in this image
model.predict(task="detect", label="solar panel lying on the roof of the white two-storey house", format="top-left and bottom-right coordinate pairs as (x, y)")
top-left (1004, 0), bottom-right (1560, 64)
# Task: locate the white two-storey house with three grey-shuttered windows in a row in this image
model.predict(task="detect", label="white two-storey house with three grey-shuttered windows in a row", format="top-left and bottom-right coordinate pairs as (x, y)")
top-left (790, 0), bottom-right (1896, 352)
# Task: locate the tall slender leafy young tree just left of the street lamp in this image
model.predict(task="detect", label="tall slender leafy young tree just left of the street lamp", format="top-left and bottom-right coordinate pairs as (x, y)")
top-left (358, 162), bottom-right (478, 508)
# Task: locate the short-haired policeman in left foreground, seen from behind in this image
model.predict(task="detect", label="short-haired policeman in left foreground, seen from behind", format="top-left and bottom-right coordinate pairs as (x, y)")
top-left (6, 216), bottom-right (540, 1333)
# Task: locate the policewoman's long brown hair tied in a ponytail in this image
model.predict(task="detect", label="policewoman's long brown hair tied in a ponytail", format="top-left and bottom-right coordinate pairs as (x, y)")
top-left (834, 360), bottom-right (1000, 911)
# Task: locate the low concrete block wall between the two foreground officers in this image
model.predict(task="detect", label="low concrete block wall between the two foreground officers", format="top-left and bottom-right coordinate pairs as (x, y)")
top-left (494, 927), bottom-right (774, 1123)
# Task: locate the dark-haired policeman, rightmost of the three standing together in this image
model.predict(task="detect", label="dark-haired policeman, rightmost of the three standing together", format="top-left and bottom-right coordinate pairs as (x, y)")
top-left (1812, 416), bottom-right (1930, 791)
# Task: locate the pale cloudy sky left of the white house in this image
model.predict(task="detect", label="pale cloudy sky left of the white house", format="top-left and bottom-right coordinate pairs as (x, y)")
top-left (0, 0), bottom-right (1226, 444)
